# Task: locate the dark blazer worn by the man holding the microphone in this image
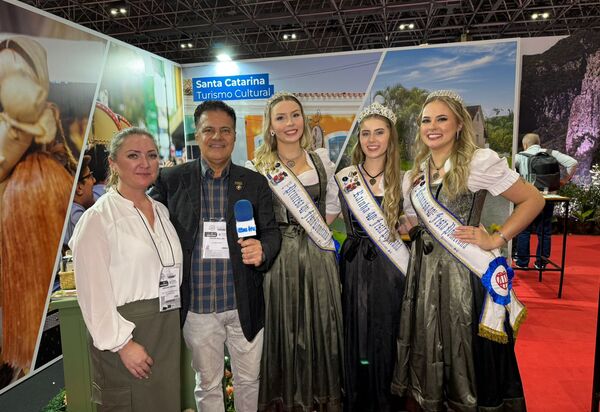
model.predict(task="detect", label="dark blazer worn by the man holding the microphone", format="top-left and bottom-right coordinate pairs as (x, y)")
top-left (150, 159), bottom-right (281, 341)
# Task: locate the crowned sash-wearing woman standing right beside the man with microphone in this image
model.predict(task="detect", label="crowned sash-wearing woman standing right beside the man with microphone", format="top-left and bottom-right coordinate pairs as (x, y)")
top-left (247, 93), bottom-right (343, 412)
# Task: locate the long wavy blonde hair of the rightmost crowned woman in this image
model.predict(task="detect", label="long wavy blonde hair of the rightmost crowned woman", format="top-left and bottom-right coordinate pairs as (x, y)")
top-left (411, 96), bottom-right (477, 199)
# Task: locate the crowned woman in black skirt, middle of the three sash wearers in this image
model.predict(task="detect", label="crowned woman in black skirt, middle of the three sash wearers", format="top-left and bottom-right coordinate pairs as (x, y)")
top-left (336, 103), bottom-right (408, 412)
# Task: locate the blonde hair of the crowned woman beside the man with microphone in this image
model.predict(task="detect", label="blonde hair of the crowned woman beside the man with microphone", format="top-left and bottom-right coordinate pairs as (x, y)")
top-left (254, 93), bottom-right (313, 172)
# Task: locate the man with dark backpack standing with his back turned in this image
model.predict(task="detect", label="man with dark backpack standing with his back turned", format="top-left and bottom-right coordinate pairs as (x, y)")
top-left (515, 133), bottom-right (577, 269)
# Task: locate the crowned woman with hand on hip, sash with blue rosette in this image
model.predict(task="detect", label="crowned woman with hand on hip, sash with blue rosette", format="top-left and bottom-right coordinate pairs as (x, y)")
top-left (392, 90), bottom-right (544, 412)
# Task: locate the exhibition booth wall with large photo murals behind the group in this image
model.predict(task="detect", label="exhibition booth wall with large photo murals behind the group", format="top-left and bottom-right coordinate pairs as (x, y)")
top-left (0, 1), bottom-right (600, 402)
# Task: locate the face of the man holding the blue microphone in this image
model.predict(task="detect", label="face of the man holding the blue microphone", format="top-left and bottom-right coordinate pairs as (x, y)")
top-left (196, 110), bottom-right (235, 170)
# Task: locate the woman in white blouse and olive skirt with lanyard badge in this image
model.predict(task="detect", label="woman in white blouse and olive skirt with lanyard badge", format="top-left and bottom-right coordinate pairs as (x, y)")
top-left (69, 128), bottom-right (182, 412)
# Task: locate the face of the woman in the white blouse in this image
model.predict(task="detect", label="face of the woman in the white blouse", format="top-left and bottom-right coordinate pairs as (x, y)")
top-left (109, 134), bottom-right (159, 191)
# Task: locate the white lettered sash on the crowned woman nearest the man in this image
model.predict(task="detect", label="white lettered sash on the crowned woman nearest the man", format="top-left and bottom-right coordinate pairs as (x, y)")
top-left (263, 162), bottom-right (335, 252)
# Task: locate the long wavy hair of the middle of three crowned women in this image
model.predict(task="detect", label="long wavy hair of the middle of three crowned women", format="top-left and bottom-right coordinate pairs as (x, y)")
top-left (352, 114), bottom-right (402, 239)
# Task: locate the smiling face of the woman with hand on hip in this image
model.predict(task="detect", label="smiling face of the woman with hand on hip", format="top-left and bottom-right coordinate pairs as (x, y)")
top-left (419, 100), bottom-right (462, 152)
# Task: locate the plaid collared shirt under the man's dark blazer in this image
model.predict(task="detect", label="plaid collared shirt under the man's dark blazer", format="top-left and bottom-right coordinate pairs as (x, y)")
top-left (190, 159), bottom-right (236, 313)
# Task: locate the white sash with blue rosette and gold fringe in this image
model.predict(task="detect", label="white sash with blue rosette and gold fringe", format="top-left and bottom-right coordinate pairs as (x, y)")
top-left (410, 165), bottom-right (527, 343)
